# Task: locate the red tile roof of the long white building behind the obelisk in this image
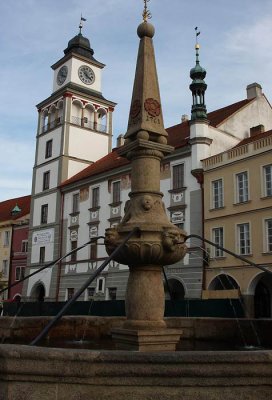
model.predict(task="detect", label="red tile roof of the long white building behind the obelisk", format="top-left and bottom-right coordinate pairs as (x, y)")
top-left (61, 99), bottom-right (253, 187)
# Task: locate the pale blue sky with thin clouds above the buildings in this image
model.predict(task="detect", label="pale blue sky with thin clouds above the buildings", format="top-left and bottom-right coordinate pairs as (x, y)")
top-left (0, 0), bottom-right (272, 201)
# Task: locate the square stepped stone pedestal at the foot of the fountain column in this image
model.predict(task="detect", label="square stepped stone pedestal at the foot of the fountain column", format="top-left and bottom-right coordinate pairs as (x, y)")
top-left (111, 329), bottom-right (182, 351)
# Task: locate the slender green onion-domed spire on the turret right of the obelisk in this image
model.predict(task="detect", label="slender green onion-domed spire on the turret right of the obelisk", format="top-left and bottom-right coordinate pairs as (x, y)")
top-left (190, 27), bottom-right (207, 121)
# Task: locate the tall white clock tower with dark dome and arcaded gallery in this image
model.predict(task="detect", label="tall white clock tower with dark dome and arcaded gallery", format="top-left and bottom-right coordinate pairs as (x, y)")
top-left (23, 25), bottom-right (116, 300)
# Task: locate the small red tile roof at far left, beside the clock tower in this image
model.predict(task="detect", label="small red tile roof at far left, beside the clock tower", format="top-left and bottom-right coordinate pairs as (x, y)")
top-left (0, 196), bottom-right (31, 222)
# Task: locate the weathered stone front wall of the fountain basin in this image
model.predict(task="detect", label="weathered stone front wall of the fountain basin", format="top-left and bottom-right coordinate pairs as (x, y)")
top-left (0, 345), bottom-right (272, 400)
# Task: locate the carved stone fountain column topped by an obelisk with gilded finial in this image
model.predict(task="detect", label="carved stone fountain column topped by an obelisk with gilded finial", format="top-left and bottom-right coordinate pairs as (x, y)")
top-left (106, 2), bottom-right (186, 350)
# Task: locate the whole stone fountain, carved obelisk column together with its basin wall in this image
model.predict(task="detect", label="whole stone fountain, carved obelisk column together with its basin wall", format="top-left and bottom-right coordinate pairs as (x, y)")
top-left (0, 0), bottom-right (272, 400)
